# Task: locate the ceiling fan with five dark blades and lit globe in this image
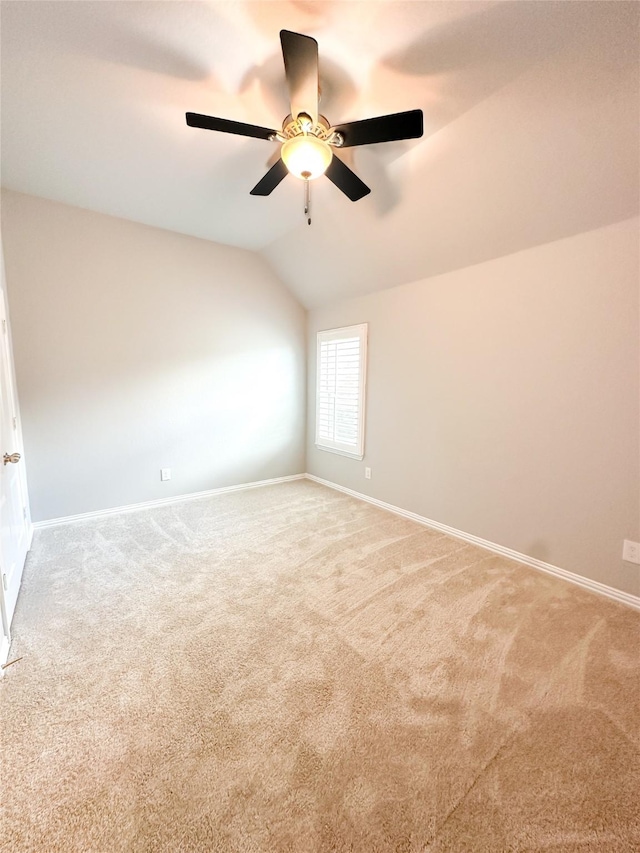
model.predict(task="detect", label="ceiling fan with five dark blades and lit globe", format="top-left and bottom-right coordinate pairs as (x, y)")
top-left (186, 30), bottom-right (423, 224)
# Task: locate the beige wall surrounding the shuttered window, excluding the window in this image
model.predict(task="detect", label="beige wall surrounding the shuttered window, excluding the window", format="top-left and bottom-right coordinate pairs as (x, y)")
top-left (307, 219), bottom-right (640, 594)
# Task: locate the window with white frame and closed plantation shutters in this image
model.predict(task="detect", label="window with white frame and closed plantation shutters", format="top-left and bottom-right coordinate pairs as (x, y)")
top-left (316, 323), bottom-right (367, 459)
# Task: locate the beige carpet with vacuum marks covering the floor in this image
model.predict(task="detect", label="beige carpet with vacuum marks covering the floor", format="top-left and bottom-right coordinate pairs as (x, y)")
top-left (0, 481), bottom-right (640, 853)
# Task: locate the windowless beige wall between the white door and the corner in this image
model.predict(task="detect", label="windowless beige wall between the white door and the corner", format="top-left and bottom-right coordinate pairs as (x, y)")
top-left (2, 191), bottom-right (305, 521)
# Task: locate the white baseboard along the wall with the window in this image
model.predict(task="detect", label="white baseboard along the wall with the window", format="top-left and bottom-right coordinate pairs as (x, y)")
top-left (306, 474), bottom-right (640, 610)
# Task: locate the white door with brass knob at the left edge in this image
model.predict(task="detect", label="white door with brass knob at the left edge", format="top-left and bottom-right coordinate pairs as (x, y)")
top-left (0, 238), bottom-right (31, 663)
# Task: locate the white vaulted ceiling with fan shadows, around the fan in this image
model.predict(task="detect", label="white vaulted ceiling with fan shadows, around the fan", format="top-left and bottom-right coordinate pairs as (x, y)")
top-left (1, 0), bottom-right (640, 306)
